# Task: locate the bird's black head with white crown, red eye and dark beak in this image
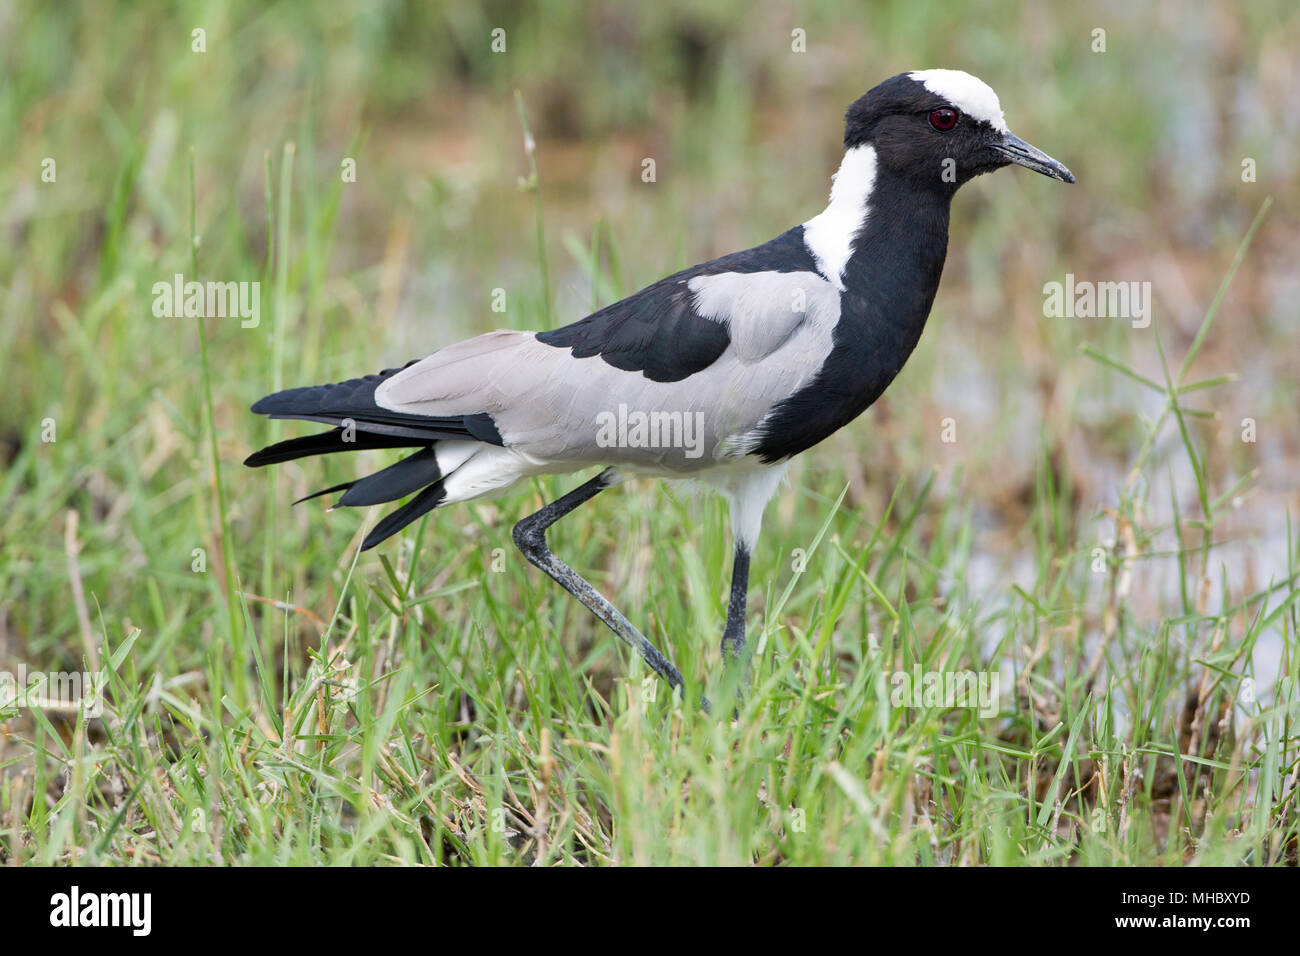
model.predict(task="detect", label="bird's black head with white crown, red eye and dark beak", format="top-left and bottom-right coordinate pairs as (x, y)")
top-left (844, 70), bottom-right (1074, 194)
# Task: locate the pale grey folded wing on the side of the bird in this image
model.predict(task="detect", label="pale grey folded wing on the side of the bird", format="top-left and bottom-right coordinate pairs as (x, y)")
top-left (374, 272), bottom-right (840, 473)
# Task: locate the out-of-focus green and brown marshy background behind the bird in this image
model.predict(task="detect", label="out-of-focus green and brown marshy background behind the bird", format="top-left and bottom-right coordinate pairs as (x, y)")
top-left (0, 0), bottom-right (1300, 868)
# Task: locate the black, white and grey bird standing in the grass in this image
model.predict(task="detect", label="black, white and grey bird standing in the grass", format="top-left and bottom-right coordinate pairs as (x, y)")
top-left (246, 70), bottom-right (1074, 702)
